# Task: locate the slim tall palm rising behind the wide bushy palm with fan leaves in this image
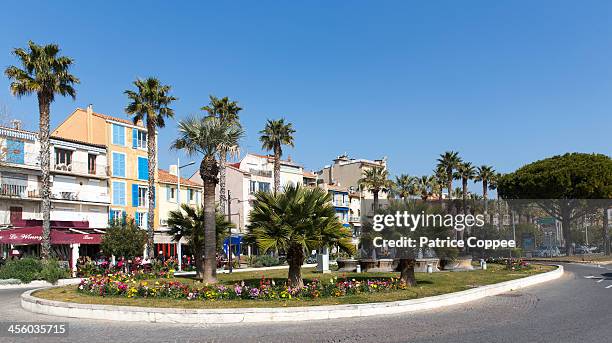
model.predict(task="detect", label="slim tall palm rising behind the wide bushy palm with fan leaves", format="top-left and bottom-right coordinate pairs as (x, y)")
top-left (259, 118), bottom-right (295, 192)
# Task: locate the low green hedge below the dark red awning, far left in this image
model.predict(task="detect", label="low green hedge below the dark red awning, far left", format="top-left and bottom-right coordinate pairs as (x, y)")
top-left (0, 257), bottom-right (70, 284)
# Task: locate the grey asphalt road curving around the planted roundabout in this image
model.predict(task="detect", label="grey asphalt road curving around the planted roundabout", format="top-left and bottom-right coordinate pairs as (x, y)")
top-left (0, 265), bottom-right (612, 343)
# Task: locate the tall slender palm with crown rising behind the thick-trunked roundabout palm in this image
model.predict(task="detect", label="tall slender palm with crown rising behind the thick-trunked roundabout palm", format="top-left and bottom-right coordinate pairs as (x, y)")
top-left (201, 95), bottom-right (242, 214)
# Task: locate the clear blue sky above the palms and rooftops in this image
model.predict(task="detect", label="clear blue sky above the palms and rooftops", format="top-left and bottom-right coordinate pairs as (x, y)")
top-left (0, 1), bottom-right (612, 185)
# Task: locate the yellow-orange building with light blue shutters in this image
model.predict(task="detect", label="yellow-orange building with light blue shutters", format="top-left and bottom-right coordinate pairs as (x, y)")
top-left (52, 105), bottom-right (159, 228)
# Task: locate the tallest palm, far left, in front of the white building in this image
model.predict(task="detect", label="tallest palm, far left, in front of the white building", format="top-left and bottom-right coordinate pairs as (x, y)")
top-left (4, 41), bottom-right (79, 259)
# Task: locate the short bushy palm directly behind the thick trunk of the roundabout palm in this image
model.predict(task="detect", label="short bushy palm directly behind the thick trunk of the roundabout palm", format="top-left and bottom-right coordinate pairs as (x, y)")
top-left (168, 204), bottom-right (234, 279)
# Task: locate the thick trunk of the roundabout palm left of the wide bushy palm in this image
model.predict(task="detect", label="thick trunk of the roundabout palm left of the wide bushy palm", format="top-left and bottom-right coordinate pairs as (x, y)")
top-left (200, 156), bottom-right (219, 283)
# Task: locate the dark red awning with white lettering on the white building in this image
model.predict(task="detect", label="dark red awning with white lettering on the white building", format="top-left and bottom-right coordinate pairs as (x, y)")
top-left (0, 226), bottom-right (102, 244)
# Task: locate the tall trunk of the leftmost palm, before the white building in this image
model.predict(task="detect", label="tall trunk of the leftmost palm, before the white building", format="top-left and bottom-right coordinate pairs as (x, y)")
top-left (38, 93), bottom-right (51, 259)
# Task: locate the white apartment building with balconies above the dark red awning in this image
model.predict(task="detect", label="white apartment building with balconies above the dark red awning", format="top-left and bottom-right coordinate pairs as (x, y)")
top-left (0, 125), bottom-right (109, 228)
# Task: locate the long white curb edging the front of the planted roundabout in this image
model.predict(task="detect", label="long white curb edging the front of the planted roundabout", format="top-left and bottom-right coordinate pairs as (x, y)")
top-left (21, 266), bottom-right (563, 324)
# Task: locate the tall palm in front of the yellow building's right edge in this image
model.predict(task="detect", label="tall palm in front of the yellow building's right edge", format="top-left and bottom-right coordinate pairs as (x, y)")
top-left (123, 77), bottom-right (176, 257)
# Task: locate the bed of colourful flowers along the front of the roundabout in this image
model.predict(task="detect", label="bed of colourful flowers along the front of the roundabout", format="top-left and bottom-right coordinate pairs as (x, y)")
top-left (78, 273), bottom-right (408, 300)
